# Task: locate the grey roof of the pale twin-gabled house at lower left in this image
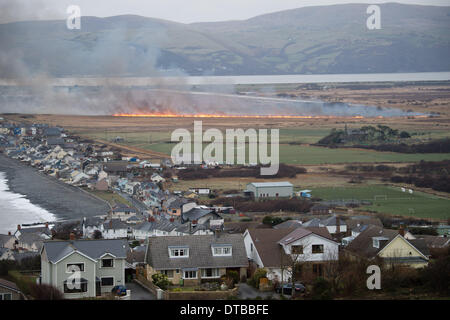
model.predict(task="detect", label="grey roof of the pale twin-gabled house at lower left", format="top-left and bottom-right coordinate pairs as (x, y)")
top-left (44, 239), bottom-right (128, 263)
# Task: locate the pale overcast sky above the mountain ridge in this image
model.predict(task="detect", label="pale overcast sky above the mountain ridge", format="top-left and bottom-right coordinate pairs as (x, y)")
top-left (0, 0), bottom-right (450, 23)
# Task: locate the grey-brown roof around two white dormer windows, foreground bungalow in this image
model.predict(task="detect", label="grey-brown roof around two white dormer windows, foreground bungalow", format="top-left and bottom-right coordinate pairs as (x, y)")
top-left (146, 233), bottom-right (248, 270)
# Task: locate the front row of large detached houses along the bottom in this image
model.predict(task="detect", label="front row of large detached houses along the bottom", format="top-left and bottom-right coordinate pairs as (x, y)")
top-left (31, 211), bottom-right (449, 298)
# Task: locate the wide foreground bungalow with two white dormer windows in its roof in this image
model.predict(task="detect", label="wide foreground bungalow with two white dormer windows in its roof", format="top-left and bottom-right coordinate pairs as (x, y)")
top-left (145, 233), bottom-right (248, 286)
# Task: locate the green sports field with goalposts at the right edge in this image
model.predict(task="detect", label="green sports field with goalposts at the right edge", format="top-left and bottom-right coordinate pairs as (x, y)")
top-left (305, 185), bottom-right (450, 220)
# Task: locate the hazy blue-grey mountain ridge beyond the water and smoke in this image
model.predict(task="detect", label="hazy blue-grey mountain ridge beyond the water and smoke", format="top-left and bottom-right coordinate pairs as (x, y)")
top-left (0, 3), bottom-right (450, 77)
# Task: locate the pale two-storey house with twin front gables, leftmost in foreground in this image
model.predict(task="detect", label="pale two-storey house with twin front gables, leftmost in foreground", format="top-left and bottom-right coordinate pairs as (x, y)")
top-left (41, 239), bottom-right (128, 299)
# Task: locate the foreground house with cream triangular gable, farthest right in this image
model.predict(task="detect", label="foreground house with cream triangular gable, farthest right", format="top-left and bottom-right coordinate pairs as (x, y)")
top-left (345, 225), bottom-right (430, 268)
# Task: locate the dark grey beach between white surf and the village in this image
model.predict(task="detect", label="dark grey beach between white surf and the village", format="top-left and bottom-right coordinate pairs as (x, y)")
top-left (0, 154), bottom-right (110, 223)
